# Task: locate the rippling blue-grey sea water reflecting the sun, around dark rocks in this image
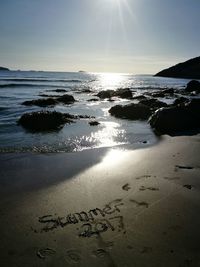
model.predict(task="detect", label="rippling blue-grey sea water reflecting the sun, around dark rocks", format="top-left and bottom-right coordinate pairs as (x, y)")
top-left (0, 71), bottom-right (188, 153)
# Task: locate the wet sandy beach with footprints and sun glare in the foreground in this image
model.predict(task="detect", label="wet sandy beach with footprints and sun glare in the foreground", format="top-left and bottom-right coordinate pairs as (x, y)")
top-left (0, 135), bottom-right (200, 267)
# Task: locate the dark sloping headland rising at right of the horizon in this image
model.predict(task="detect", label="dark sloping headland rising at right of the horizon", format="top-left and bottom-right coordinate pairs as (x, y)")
top-left (155, 57), bottom-right (200, 79)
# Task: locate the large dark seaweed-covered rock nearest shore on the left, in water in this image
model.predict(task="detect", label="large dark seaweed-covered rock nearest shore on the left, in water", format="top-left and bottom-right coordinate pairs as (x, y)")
top-left (18, 111), bottom-right (74, 132)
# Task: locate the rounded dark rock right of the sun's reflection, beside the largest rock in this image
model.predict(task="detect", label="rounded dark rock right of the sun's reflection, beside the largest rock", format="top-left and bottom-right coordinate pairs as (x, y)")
top-left (109, 103), bottom-right (151, 120)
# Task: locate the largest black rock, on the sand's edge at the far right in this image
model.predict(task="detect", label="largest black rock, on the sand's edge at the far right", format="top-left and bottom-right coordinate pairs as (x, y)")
top-left (149, 99), bottom-right (200, 135)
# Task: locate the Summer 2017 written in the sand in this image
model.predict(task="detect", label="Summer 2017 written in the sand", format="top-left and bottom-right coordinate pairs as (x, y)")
top-left (39, 199), bottom-right (124, 237)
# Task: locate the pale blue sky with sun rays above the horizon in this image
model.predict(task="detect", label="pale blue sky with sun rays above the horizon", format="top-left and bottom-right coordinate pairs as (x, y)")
top-left (0, 0), bottom-right (200, 74)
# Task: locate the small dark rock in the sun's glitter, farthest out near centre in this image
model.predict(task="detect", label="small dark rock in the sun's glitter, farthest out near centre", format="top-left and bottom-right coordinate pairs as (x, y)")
top-left (97, 88), bottom-right (132, 99)
